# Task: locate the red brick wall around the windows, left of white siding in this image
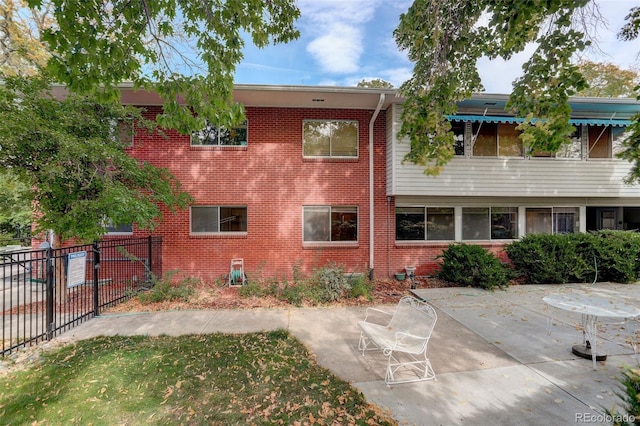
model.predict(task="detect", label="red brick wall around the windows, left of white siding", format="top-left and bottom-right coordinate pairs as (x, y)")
top-left (124, 107), bottom-right (386, 281)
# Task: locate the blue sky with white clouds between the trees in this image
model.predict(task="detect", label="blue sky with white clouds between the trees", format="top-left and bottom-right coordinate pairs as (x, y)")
top-left (235, 0), bottom-right (640, 93)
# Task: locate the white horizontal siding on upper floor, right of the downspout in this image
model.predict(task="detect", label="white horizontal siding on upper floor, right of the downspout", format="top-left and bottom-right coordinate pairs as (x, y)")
top-left (387, 107), bottom-right (640, 198)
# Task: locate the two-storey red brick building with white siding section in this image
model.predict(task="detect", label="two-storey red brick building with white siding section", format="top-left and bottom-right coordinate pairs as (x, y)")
top-left (112, 85), bottom-right (640, 281)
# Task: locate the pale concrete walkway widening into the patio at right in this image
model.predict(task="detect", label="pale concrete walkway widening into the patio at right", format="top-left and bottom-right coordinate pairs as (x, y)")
top-left (59, 284), bottom-right (640, 425)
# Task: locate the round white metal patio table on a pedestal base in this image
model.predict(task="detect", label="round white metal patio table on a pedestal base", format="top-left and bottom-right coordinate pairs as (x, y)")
top-left (542, 293), bottom-right (640, 369)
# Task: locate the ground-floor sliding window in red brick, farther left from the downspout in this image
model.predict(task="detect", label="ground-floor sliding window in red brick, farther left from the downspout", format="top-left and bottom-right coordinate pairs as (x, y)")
top-left (191, 206), bottom-right (247, 234)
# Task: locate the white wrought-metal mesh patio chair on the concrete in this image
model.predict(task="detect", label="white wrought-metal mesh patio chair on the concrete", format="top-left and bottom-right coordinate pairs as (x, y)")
top-left (358, 296), bottom-right (438, 385)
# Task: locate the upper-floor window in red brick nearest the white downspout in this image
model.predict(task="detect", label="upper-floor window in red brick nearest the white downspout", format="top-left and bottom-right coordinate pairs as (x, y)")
top-left (302, 120), bottom-right (358, 157)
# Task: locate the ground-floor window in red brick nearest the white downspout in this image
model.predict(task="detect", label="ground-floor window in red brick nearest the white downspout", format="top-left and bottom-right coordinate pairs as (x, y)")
top-left (302, 206), bottom-right (358, 242)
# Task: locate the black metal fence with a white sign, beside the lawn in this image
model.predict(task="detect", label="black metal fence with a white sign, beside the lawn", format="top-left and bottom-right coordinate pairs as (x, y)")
top-left (0, 237), bottom-right (162, 356)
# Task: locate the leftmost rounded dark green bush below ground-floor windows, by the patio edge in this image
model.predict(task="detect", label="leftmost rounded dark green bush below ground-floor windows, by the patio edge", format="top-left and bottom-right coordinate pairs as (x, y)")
top-left (436, 244), bottom-right (510, 290)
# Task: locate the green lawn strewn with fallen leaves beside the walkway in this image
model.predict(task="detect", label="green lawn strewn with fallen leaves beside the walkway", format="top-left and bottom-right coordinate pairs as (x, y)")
top-left (0, 331), bottom-right (395, 425)
